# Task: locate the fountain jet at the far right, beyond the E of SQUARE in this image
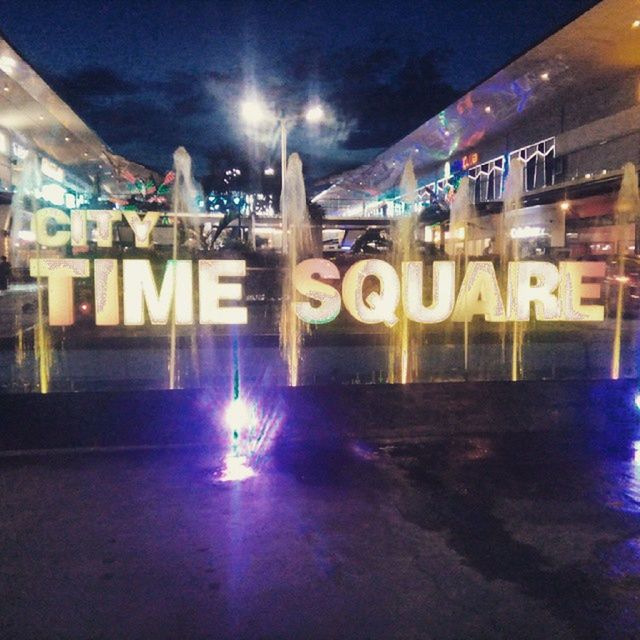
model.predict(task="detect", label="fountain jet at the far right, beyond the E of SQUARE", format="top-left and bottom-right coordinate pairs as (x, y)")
top-left (611, 162), bottom-right (640, 380)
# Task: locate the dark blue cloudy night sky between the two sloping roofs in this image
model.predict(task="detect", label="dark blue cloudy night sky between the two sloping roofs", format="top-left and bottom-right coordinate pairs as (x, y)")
top-left (0, 0), bottom-right (594, 177)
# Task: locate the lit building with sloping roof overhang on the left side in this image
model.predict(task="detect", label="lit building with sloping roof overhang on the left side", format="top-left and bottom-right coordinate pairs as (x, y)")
top-left (0, 28), bottom-right (152, 253)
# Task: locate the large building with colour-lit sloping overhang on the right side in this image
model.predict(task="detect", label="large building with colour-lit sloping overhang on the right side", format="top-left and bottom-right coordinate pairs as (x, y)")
top-left (314, 0), bottom-right (640, 257)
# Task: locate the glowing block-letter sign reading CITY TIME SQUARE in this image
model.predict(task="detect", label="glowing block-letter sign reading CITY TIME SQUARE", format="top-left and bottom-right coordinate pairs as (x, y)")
top-left (30, 208), bottom-right (606, 327)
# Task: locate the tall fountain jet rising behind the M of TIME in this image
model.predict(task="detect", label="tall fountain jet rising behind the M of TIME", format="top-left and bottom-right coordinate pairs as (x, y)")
top-left (168, 147), bottom-right (199, 389)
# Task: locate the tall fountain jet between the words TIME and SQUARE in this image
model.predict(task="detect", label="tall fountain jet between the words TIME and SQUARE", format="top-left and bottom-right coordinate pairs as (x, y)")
top-left (280, 153), bottom-right (313, 387)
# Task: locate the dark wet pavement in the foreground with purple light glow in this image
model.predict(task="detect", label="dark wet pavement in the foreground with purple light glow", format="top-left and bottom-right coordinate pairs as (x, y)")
top-left (0, 424), bottom-right (640, 640)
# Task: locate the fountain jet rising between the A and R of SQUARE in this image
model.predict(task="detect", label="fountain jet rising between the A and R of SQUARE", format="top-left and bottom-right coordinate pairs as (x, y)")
top-left (498, 158), bottom-right (526, 382)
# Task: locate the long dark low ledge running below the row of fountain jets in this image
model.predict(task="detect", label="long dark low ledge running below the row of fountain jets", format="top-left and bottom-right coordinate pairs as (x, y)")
top-left (0, 380), bottom-right (638, 451)
